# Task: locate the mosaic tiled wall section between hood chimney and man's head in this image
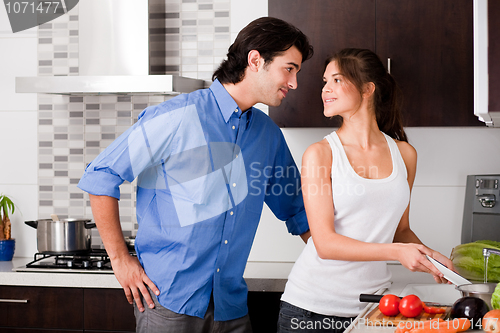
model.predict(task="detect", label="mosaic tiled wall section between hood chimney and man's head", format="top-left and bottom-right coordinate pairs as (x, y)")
top-left (149, 0), bottom-right (231, 80)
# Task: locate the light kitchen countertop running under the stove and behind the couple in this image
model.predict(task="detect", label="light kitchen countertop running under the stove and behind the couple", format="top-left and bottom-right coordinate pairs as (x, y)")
top-left (0, 257), bottom-right (434, 293)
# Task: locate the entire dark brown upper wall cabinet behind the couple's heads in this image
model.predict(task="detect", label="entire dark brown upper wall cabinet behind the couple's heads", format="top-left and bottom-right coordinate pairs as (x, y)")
top-left (269, 0), bottom-right (484, 127)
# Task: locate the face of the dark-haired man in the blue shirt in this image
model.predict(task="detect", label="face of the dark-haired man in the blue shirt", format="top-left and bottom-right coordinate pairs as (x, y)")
top-left (254, 46), bottom-right (302, 106)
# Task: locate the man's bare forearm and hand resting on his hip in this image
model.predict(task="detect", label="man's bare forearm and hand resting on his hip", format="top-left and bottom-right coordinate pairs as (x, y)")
top-left (89, 194), bottom-right (160, 312)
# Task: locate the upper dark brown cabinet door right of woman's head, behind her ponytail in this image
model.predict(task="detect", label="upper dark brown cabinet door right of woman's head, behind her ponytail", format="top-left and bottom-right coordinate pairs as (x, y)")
top-left (376, 0), bottom-right (478, 126)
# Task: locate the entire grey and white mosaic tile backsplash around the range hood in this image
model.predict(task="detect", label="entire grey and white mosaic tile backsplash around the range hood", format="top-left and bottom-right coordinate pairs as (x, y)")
top-left (38, 0), bottom-right (231, 248)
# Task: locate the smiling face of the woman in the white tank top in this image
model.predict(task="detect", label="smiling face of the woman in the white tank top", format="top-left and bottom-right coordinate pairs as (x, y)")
top-left (321, 61), bottom-right (362, 119)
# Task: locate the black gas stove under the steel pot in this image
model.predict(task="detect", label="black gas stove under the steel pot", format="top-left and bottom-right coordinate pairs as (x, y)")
top-left (15, 249), bottom-right (120, 274)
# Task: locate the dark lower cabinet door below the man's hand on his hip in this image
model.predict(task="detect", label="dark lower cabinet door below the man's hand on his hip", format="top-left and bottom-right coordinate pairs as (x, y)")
top-left (84, 289), bottom-right (135, 332)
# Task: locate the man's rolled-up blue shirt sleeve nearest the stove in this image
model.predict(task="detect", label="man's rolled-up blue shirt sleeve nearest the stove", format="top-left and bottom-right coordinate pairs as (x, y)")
top-left (78, 104), bottom-right (183, 199)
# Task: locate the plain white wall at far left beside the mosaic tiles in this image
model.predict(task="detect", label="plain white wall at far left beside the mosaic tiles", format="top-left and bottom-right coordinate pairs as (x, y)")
top-left (0, 6), bottom-right (38, 257)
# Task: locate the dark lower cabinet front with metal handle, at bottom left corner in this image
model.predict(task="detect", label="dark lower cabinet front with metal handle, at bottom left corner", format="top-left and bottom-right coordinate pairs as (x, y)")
top-left (0, 286), bottom-right (83, 331)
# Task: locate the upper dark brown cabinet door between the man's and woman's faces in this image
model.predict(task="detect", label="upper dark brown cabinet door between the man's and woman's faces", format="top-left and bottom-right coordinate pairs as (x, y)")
top-left (268, 0), bottom-right (375, 127)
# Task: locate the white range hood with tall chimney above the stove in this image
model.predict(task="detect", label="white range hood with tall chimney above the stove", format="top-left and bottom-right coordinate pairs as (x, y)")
top-left (16, 0), bottom-right (205, 95)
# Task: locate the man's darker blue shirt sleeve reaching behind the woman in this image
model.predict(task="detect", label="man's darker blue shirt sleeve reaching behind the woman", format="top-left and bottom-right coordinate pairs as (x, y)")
top-left (265, 133), bottom-right (309, 235)
